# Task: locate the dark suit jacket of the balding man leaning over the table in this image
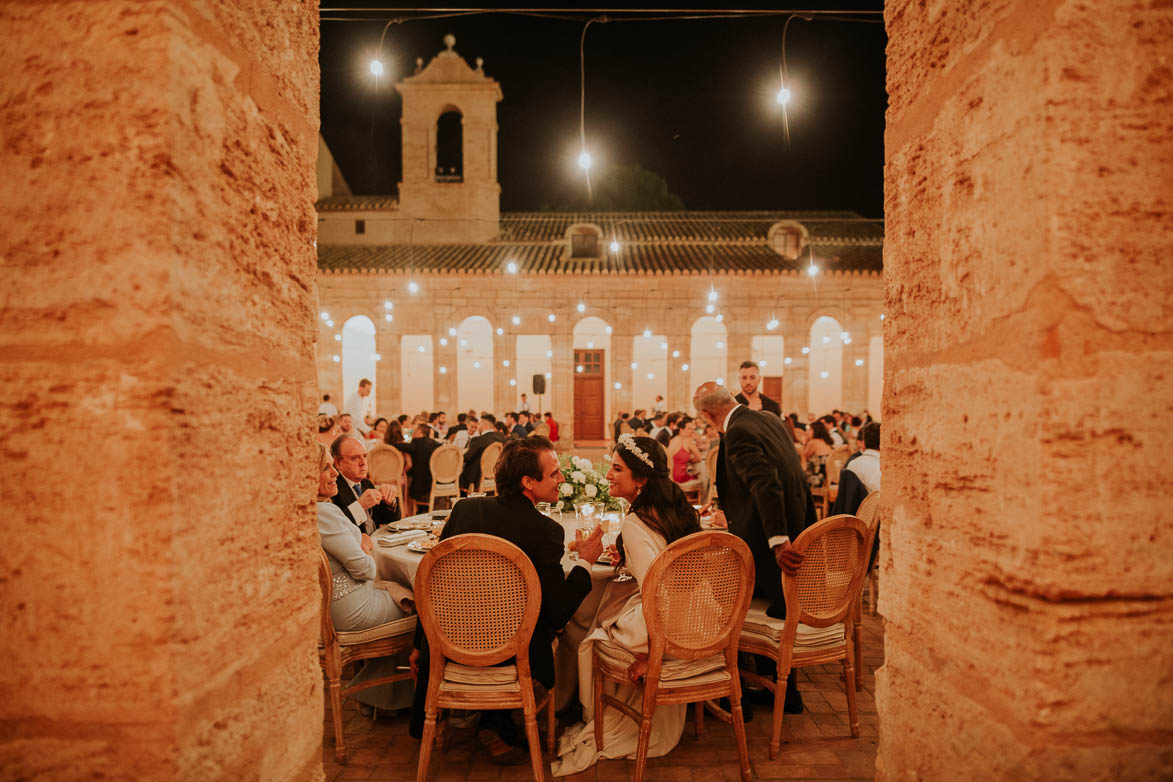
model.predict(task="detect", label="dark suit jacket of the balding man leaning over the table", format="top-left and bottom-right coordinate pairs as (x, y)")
top-left (717, 407), bottom-right (815, 618)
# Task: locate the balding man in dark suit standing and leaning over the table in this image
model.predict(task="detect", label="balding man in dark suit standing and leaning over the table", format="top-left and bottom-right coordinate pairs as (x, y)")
top-left (692, 382), bottom-right (816, 714)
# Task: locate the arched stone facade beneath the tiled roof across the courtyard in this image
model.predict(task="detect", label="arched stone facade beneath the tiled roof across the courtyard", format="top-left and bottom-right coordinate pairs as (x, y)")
top-left (318, 272), bottom-right (883, 441)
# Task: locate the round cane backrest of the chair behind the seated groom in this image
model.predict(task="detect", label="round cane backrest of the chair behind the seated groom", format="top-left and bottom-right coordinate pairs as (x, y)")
top-left (415, 535), bottom-right (542, 666)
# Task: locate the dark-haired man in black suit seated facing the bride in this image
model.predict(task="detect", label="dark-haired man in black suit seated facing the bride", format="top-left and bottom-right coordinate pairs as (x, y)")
top-left (411, 436), bottom-right (603, 763)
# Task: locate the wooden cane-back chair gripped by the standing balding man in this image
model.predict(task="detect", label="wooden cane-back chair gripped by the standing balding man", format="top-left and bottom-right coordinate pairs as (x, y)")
top-left (740, 514), bottom-right (868, 760)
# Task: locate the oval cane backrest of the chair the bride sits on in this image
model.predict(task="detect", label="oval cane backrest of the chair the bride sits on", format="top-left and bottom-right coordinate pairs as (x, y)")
top-left (642, 530), bottom-right (754, 659)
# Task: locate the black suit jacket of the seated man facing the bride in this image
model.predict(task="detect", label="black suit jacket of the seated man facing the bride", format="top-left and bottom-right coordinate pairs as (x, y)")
top-left (411, 497), bottom-right (591, 735)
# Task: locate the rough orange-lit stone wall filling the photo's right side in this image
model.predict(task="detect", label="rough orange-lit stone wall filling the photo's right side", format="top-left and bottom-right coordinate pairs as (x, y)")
top-left (876, 0), bottom-right (1173, 780)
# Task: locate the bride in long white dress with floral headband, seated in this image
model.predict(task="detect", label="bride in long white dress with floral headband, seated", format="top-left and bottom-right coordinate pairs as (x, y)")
top-left (551, 434), bottom-right (700, 776)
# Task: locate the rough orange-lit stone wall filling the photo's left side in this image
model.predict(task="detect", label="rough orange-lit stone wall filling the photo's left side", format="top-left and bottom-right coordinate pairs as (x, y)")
top-left (0, 0), bottom-right (323, 781)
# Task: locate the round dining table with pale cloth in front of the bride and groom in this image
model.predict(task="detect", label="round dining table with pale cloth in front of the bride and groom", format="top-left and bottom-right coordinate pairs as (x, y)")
top-left (373, 514), bottom-right (616, 709)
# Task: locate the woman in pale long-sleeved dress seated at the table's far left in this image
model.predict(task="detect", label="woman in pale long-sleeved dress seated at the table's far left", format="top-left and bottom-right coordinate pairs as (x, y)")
top-left (318, 444), bottom-right (415, 716)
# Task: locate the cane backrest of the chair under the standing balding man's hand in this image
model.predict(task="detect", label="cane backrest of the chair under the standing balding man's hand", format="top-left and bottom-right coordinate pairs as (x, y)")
top-left (782, 514), bottom-right (869, 628)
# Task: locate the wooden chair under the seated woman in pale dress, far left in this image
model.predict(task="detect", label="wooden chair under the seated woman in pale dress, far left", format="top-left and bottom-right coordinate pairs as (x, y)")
top-left (318, 549), bottom-right (415, 763)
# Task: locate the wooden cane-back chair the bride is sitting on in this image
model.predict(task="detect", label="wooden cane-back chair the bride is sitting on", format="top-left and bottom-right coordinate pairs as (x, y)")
top-left (591, 530), bottom-right (753, 782)
